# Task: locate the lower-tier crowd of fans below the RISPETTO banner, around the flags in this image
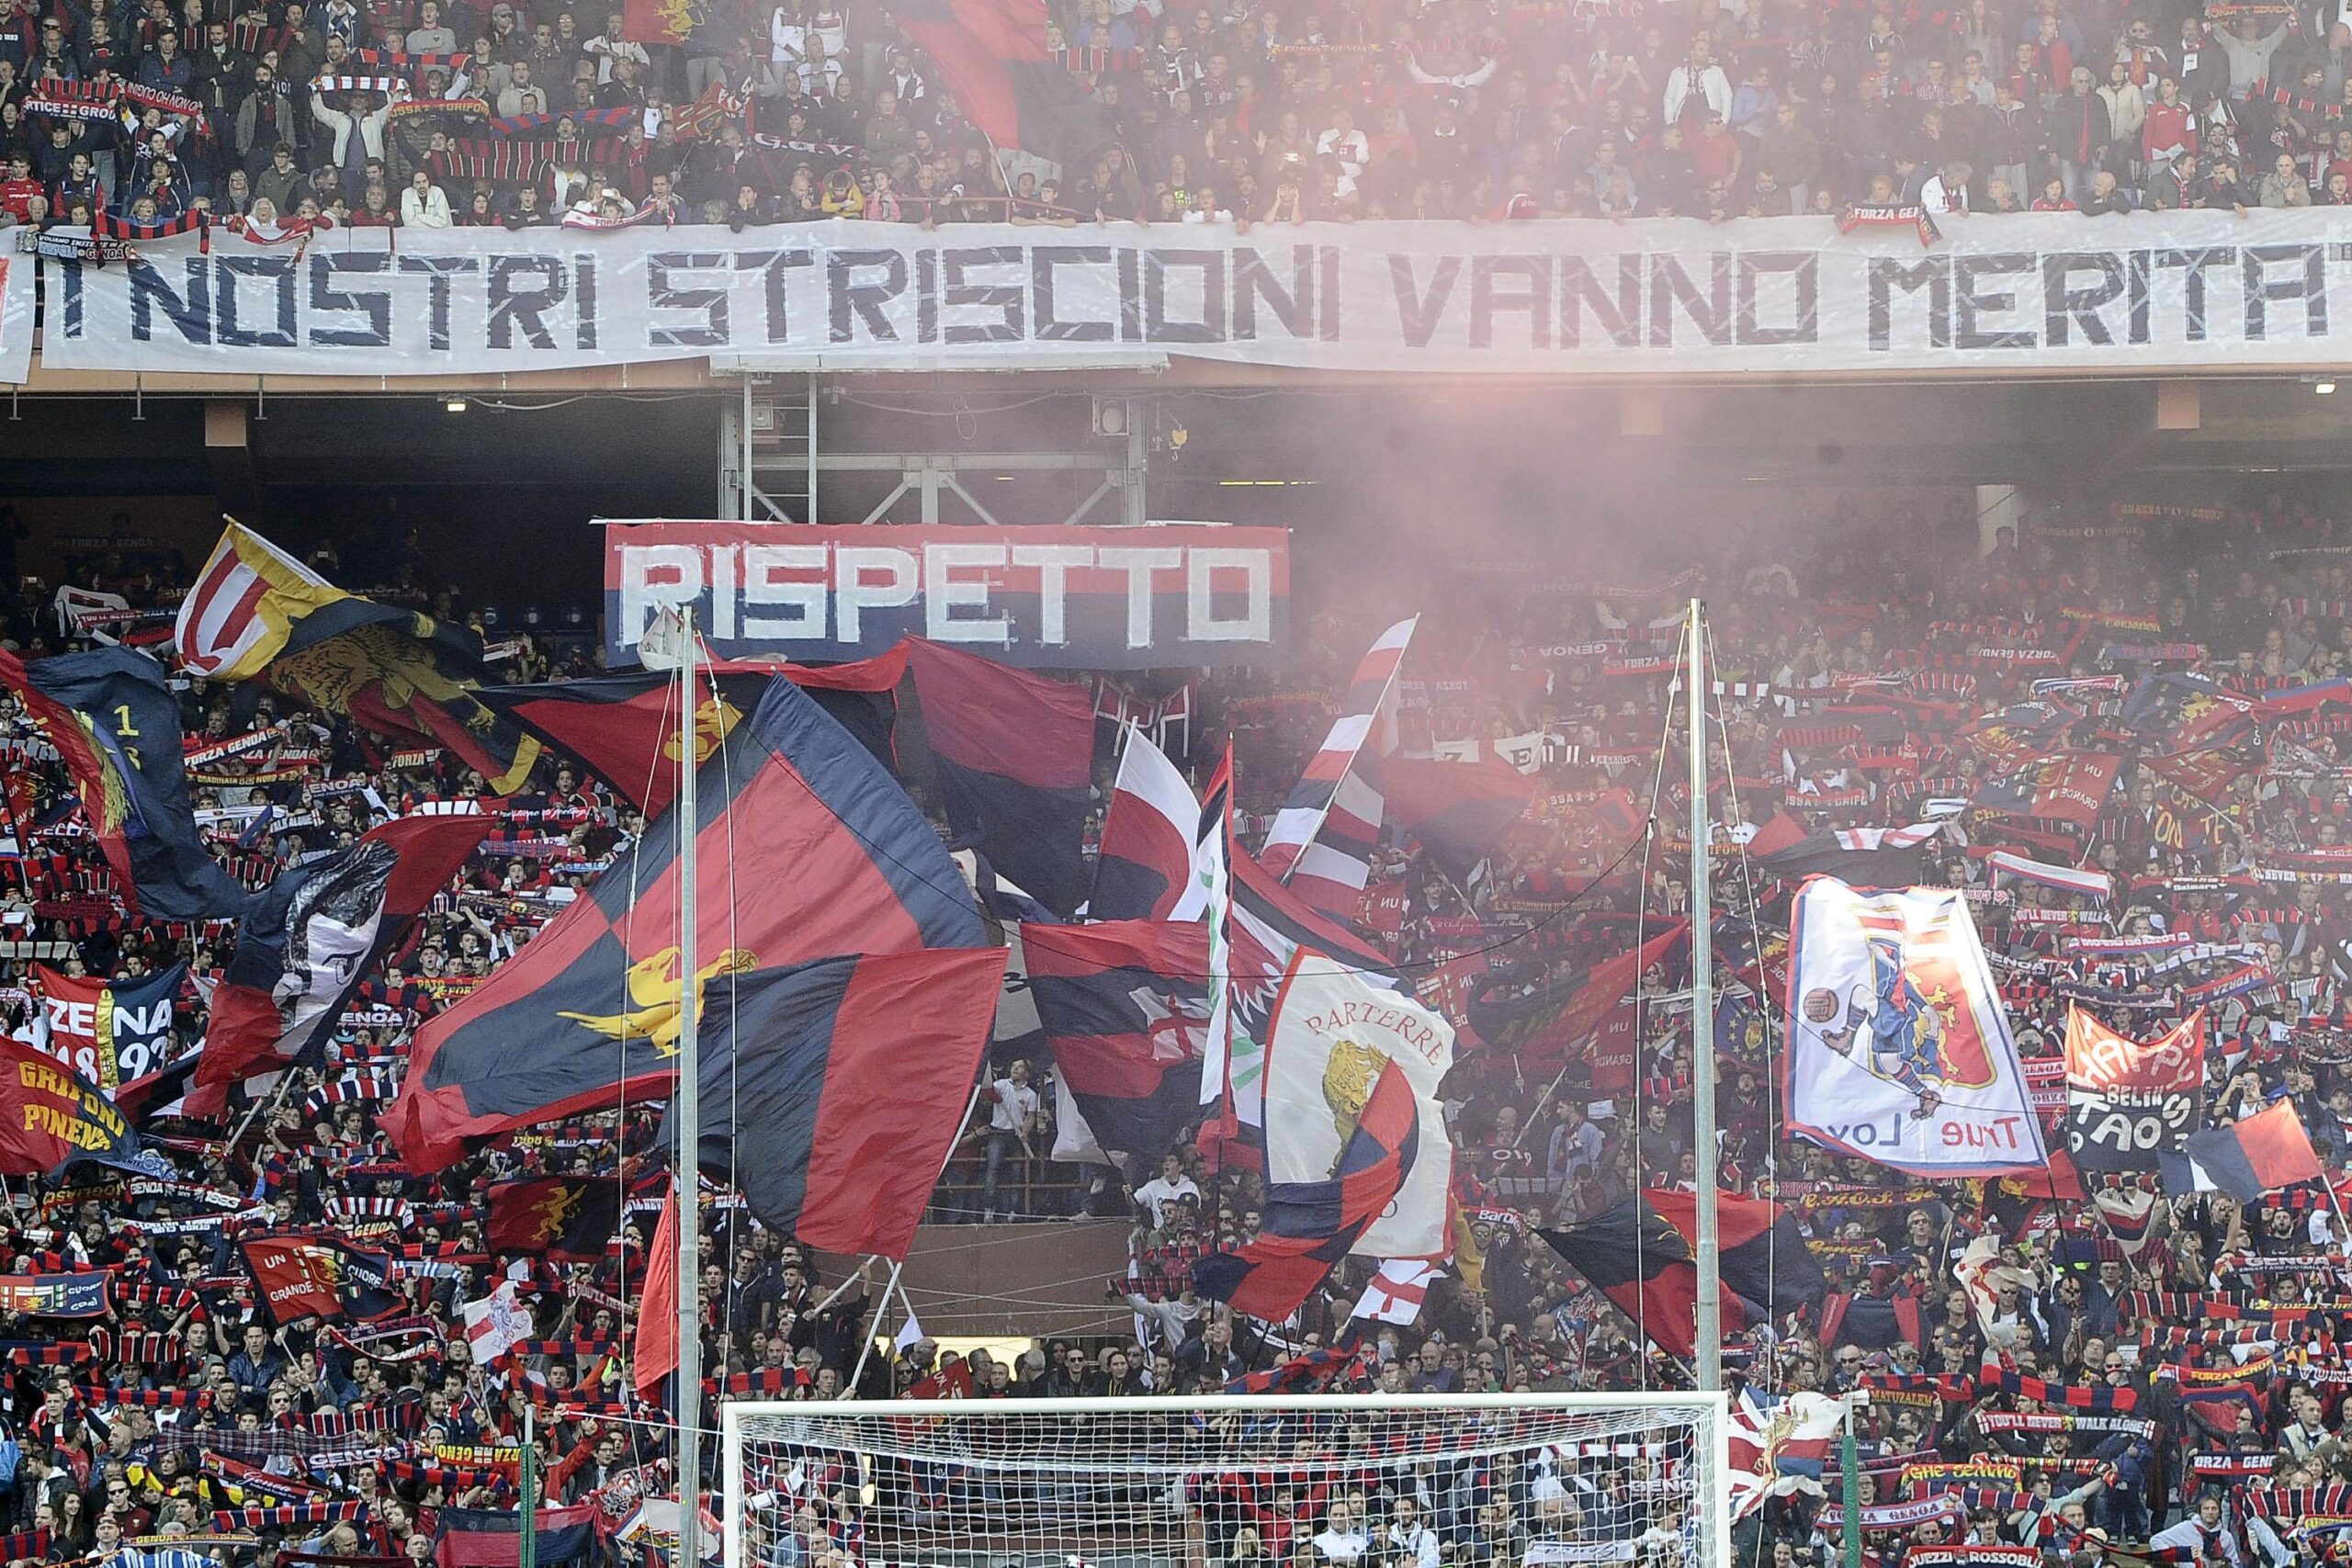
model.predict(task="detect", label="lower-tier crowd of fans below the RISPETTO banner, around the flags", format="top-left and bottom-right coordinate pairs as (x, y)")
top-left (0, 493), bottom-right (2352, 1568)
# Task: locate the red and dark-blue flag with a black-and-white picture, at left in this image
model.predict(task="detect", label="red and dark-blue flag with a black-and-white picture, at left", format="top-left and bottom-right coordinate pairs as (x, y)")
top-left (195, 816), bottom-right (489, 1109)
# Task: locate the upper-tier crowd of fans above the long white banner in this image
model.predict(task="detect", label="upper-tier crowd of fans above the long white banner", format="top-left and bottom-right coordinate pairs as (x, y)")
top-left (0, 0), bottom-right (2352, 232)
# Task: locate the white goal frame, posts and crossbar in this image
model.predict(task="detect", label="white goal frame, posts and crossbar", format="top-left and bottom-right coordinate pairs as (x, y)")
top-left (719, 1392), bottom-right (1731, 1568)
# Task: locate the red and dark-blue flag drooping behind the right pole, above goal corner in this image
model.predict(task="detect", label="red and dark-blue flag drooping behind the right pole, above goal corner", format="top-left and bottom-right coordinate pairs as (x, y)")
top-left (1538, 1187), bottom-right (1830, 1357)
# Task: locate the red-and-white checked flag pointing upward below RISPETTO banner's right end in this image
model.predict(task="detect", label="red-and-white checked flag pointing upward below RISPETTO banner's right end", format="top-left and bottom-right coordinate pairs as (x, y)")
top-left (1259, 616), bottom-right (1420, 915)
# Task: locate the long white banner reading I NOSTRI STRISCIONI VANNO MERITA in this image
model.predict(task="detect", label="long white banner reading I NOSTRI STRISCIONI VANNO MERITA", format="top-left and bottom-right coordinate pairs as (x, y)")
top-left (32, 207), bottom-right (2352, 381)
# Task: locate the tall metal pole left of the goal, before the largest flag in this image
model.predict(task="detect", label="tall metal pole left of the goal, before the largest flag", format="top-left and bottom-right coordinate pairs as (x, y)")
top-left (671, 609), bottom-right (703, 1568)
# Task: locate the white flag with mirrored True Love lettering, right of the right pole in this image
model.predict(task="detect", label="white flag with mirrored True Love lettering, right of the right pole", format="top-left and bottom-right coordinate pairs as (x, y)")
top-left (1782, 877), bottom-right (2049, 1176)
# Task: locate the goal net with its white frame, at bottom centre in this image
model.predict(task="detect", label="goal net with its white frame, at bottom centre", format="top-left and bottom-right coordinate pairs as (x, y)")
top-left (722, 1394), bottom-right (1731, 1568)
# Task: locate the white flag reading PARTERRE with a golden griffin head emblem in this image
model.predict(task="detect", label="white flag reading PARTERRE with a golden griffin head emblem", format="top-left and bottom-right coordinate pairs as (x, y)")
top-left (1265, 947), bottom-right (1453, 1258)
